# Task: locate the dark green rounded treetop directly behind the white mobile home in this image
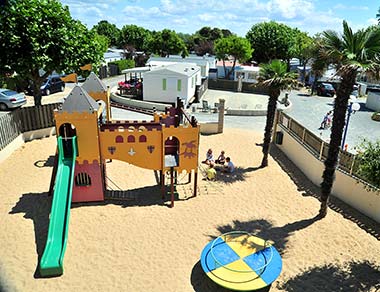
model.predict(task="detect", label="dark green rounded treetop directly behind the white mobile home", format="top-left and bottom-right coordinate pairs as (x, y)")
top-left (149, 29), bottom-right (188, 57)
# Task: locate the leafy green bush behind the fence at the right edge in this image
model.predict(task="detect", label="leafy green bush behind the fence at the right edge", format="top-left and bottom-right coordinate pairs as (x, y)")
top-left (358, 139), bottom-right (380, 188)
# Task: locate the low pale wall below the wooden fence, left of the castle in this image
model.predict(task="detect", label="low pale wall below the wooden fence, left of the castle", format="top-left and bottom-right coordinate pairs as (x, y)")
top-left (0, 127), bottom-right (55, 163)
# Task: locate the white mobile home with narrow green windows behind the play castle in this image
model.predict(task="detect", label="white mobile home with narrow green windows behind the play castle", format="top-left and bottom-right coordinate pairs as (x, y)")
top-left (143, 63), bottom-right (201, 105)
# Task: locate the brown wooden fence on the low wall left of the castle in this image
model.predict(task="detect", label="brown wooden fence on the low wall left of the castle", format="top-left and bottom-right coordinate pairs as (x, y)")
top-left (0, 103), bottom-right (62, 150)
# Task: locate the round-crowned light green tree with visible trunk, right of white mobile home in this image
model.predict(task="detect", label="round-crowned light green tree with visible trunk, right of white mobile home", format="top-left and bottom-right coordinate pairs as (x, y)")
top-left (215, 35), bottom-right (253, 79)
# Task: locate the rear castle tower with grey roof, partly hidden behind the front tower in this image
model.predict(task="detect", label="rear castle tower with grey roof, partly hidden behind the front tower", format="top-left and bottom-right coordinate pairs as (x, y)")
top-left (82, 72), bottom-right (111, 122)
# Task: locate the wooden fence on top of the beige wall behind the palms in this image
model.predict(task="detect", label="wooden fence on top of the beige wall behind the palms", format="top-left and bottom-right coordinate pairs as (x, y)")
top-left (279, 111), bottom-right (362, 178)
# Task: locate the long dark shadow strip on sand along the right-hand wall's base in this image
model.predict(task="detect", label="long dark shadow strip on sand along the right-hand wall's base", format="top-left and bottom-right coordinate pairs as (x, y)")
top-left (270, 145), bottom-right (380, 240)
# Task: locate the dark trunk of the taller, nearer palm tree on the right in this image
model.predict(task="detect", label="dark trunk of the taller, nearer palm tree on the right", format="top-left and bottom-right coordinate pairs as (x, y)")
top-left (319, 67), bottom-right (357, 217)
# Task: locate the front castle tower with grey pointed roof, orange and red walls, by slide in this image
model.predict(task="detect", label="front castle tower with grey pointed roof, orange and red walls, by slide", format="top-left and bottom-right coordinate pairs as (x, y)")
top-left (55, 86), bottom-right (104, 202)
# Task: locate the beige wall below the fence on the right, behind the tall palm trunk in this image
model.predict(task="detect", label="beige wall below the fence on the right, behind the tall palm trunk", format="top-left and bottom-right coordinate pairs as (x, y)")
top-left (277, 126), bottom-right (380, 223)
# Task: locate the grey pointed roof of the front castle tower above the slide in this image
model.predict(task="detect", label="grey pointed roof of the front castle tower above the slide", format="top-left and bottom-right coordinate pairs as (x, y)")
top-left (62, 85), bottom-right (99, 113)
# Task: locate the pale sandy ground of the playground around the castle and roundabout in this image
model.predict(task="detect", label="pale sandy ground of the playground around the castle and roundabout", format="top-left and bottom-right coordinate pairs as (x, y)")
top-left (0, 130), bottom-right (380, 292)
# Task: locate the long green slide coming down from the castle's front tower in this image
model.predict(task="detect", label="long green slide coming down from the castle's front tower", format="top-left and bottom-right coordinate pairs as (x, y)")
top-left (40, 137), bottom-right (77, 277)
